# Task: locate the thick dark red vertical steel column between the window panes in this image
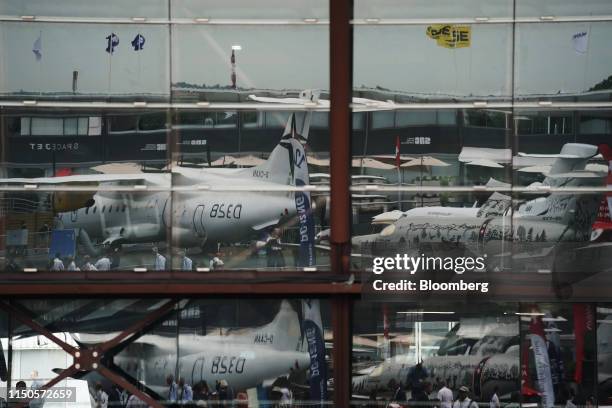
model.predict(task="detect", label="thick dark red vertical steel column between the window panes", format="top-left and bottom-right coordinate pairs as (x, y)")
top-left (329, 0), bottom-right (353, 408)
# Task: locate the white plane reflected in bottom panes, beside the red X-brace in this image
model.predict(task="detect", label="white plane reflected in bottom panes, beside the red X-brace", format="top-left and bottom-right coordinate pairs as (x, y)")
top-left (73, 301), bottom-right (310, 395)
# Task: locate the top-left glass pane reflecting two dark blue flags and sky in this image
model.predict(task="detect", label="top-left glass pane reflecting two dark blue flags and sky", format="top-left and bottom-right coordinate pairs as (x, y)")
top-left (0, 22), bottom-right (170, 101)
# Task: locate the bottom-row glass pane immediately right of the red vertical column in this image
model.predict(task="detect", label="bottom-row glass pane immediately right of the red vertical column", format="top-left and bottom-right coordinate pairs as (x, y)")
top-left (352, 301), bottom-right (521, 406)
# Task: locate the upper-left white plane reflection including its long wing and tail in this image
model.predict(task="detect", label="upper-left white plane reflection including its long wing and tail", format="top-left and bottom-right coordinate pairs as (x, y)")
top-left (0, 96), bottom-right (317, 252)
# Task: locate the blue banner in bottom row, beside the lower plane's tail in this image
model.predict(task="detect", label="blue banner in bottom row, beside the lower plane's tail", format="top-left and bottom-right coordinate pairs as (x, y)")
top-left (302, 299), bottom-right (327, 406)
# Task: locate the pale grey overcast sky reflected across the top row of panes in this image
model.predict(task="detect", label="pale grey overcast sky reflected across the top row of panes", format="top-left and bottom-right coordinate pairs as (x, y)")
top-left (0, 18), bottom-right (612, 96)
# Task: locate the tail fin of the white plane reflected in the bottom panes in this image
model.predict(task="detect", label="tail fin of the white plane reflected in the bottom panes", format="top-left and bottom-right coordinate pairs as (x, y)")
top-left (249, 300), bottom-right (301, 351)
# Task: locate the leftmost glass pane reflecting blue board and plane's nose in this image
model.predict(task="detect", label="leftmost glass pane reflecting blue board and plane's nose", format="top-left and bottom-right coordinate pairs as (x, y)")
top-left (5, 192), bottom-right (171, 274)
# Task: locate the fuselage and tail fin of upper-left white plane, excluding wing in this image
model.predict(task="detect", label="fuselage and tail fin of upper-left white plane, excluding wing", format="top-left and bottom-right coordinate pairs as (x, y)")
top-left (53, 115), bottom-right (308, 250)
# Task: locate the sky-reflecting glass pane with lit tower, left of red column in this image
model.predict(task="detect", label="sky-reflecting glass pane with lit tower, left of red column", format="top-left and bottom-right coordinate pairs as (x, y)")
top-left (172, 25), bottom-right (329, 102)
